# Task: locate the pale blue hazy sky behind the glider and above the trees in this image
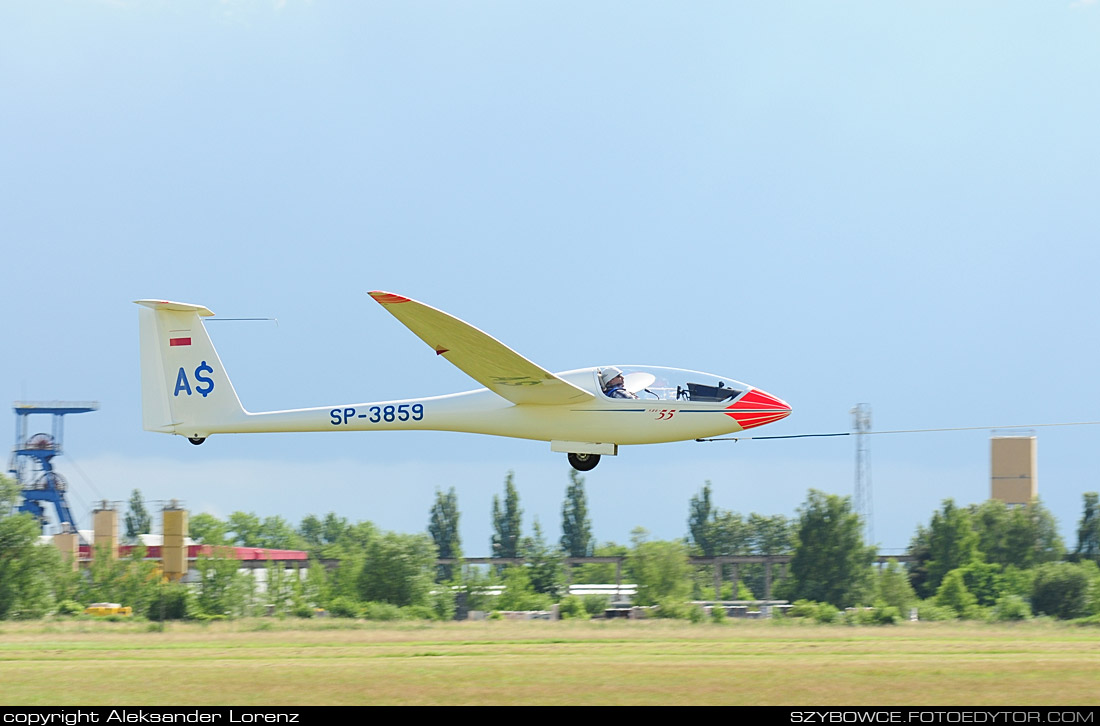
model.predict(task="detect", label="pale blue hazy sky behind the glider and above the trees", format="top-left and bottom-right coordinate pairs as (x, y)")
top-left (0, 0), bottom-right (1100, 557)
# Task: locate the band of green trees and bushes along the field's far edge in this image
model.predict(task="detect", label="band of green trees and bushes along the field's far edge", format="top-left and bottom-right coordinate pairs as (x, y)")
top-left (0, 470), bottom-right (1100, 623)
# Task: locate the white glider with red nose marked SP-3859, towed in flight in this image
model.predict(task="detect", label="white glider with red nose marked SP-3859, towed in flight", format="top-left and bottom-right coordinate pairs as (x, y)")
top-left (135, 292), bottom-right (791, 471)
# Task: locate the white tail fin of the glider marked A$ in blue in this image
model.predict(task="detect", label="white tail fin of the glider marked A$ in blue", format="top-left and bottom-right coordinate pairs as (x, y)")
top-left (134, 300), bottom-right (246, 440)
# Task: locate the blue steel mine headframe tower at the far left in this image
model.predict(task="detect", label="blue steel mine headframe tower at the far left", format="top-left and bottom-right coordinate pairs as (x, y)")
top-left (10, 402), bottom-right (99, 531)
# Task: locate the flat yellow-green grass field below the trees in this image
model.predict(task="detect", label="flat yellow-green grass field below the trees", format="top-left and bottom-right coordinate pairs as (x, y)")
top-left (0, 619), bottom-right (1100, 706)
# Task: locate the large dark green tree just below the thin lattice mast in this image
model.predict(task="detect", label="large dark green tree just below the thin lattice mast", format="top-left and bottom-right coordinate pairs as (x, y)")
top-left (787, 490), bottom-right (875, 607)
